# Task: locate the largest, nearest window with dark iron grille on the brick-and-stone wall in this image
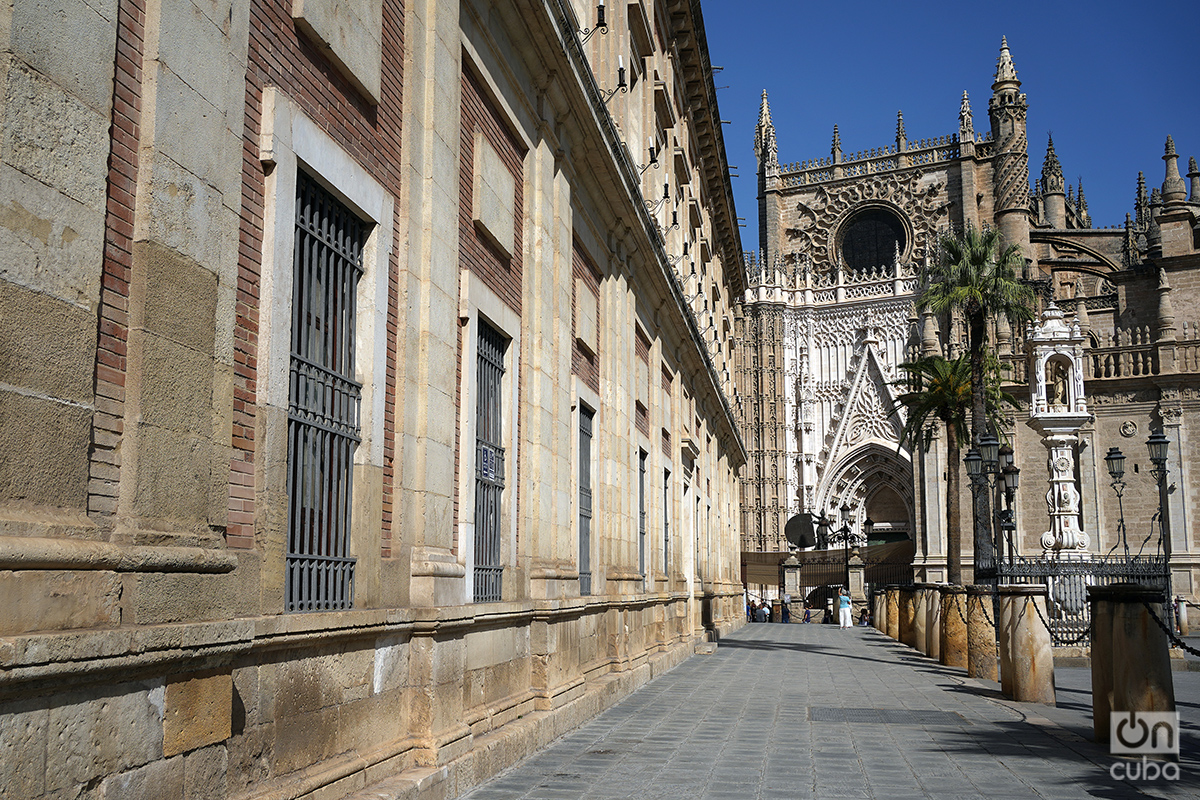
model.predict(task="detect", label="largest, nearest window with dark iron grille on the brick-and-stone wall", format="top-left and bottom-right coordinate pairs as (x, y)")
top-left (284, 173), bottom-right (367, 612)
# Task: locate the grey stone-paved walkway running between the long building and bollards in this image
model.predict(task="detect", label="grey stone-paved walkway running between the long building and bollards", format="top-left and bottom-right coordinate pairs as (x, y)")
top-left (463, 625), bottom-right (1200, 800)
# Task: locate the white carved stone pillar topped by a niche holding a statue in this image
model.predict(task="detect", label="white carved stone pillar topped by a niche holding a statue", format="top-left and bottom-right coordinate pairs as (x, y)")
top-left (1026, 303), bottom-right (1092, 558)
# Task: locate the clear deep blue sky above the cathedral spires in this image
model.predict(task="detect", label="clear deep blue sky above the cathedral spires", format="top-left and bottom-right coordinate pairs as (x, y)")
top-left (702, 0), bottom-right (1200, 255)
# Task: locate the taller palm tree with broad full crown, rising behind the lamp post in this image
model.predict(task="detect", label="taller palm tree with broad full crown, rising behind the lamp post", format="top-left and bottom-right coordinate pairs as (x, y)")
top-left (918, 225), bottom-right (1034, 446)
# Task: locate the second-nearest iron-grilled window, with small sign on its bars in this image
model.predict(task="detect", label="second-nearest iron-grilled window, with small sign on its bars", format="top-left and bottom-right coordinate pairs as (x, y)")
top-left (473, 320), bottom-right (509, 602)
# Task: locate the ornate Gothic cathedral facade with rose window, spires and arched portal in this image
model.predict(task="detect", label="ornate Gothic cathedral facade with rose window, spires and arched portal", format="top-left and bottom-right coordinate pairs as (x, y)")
top-left (736, 40), bottom-right (1200, 597)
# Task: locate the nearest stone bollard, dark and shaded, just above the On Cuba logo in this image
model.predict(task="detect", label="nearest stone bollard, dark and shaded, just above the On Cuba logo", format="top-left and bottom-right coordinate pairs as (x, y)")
top-left (1087, 583), bottom-right (1175, 742)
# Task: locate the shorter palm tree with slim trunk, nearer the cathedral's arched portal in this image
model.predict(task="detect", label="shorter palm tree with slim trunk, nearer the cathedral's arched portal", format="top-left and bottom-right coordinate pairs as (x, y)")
top-left (895, 354), bottom-right (971, 585)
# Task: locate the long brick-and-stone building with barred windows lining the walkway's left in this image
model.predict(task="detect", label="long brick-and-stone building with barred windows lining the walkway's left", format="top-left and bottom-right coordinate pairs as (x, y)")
top-left (0, 0), bottom-right (745, 800)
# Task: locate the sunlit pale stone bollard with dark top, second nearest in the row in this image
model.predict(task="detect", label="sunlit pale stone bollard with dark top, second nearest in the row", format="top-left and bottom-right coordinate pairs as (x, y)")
top-left (996, 584), bottom-right (1055, 705)
